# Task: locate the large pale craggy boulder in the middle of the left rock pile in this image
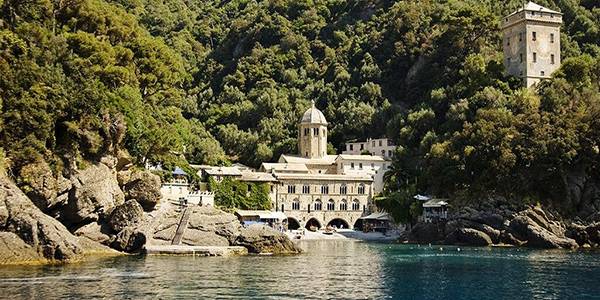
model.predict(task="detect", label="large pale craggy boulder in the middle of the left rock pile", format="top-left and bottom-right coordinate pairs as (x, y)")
top-left (59, 163), bottom-right (125, 225)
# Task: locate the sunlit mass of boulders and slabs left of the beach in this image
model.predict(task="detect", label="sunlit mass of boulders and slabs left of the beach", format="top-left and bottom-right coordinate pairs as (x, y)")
top-left (0, 156), bottom-right (302, 265)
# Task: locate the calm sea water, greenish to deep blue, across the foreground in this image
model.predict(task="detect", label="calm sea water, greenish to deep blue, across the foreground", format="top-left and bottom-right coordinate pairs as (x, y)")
top-left (0, 241), bottom-right (600, 299)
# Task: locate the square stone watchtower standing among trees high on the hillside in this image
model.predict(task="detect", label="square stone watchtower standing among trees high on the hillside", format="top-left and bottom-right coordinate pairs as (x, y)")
top-left (501, 2), bottom-right (562, 87)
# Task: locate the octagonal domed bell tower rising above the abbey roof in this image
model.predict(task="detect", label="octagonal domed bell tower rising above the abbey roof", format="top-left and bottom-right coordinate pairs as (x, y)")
top-left (298, 101), bottom-right (327, 158)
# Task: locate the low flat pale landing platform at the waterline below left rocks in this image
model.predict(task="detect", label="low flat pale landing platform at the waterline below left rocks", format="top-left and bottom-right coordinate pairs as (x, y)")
top-left (144, 245), bottom-right (248, 256)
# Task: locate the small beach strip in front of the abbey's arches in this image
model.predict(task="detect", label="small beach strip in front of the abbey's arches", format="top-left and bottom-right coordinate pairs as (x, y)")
top-left (286, 229), bottom-right (398, 242)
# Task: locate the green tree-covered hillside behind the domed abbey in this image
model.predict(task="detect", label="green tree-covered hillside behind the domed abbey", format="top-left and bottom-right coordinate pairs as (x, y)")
top-left (0, 0), bottom-right (600, 211)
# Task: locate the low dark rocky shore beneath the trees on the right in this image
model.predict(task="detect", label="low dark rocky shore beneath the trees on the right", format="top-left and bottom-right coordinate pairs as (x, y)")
top-left (406, 197), bottom-right (600, 249)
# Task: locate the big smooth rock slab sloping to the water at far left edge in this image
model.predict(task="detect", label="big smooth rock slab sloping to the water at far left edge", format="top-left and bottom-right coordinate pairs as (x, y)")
top-left (0, 174), bottom-right (82, 261)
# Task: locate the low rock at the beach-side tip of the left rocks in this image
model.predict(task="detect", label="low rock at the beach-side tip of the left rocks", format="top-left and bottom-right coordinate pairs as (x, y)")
top-left (234, 224), bottom-right (302, 254)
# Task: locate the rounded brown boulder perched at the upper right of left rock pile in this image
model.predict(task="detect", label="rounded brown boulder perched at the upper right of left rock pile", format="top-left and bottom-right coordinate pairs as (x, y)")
top-left (119, 170), bottom-right (162, 211)
